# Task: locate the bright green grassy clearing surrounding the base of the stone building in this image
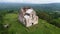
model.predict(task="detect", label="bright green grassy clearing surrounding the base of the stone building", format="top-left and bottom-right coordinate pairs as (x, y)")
top-left (3, 13), bottom-right (60, 34)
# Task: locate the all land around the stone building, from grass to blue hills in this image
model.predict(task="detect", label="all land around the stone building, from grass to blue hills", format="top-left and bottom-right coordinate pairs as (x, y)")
top-left (0, 3), bottom-right (60, 34)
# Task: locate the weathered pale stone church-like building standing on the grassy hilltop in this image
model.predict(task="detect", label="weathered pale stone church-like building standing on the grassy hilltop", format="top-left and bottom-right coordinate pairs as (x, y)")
top-left (19, 7), bottom-right (38, 27)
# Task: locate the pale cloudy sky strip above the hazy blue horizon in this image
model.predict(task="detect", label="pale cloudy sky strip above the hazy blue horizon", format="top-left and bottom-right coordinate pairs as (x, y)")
top-left (0, 0), bottom-right (60, 4)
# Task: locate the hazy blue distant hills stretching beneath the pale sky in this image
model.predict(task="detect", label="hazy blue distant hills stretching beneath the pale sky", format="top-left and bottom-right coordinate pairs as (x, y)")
top-left (0, 3), bottom-right (60, 11)
